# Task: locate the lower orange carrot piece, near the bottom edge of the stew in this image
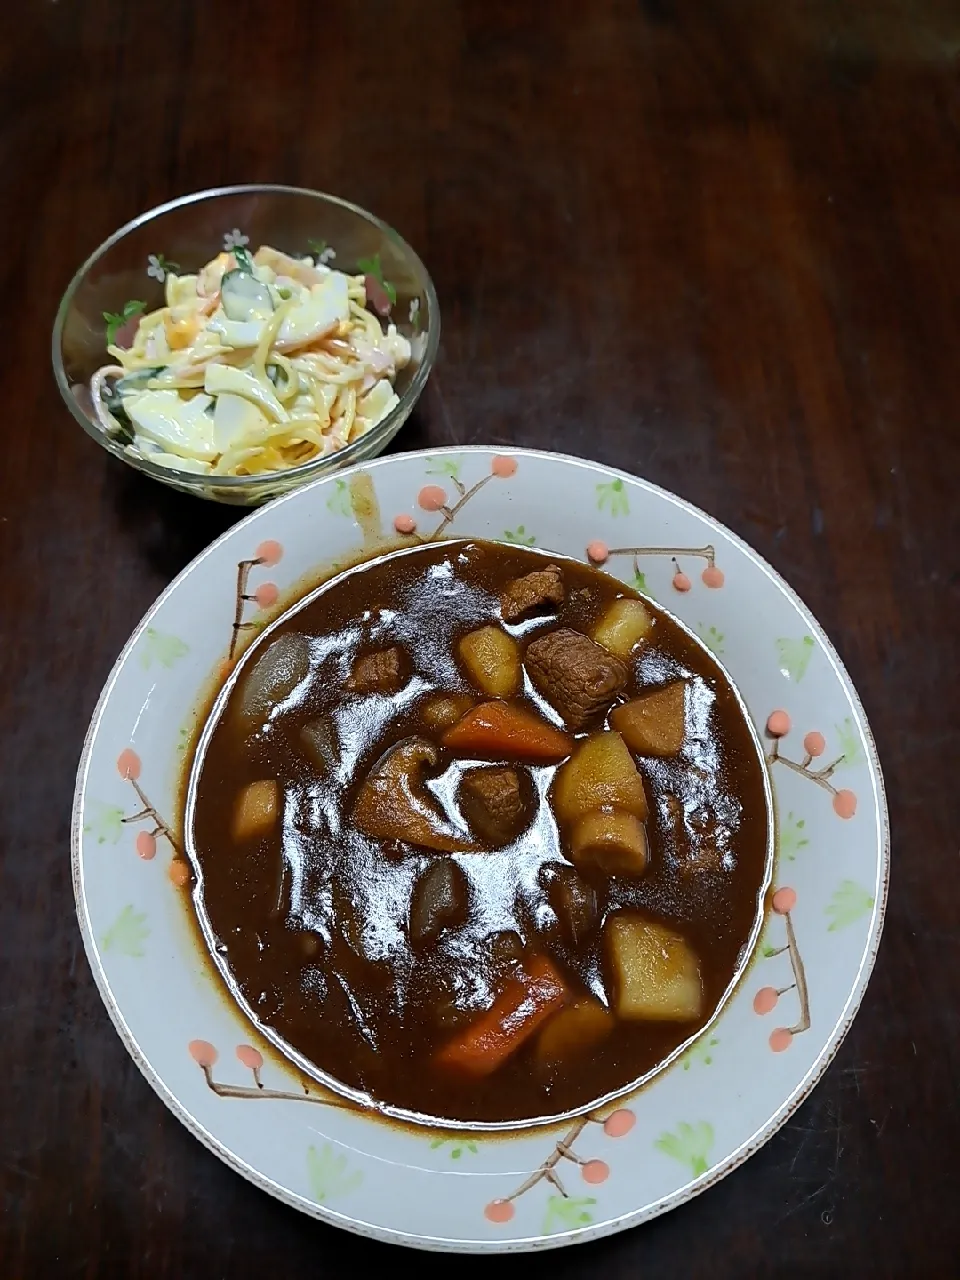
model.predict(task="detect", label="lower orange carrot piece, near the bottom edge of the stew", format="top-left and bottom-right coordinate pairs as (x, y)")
top-left (436, 956), bottom-right (567, 1075)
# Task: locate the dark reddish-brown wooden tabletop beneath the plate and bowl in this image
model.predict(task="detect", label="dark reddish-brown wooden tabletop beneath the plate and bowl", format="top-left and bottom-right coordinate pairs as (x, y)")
top-left (0, 0), bottom-right (960, 1280)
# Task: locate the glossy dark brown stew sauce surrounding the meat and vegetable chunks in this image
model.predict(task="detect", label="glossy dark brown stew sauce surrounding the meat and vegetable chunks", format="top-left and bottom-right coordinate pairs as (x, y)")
top-left (188, 541), bottom-right (771, 1124)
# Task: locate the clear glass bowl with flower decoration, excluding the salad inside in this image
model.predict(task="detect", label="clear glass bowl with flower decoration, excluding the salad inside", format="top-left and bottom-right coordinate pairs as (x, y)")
top-left (52, 186), bottom-right (440, 507)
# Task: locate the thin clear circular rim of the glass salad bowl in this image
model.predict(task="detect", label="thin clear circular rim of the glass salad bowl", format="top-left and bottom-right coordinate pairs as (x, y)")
top-left (52, 182), bottom-right (440, 493)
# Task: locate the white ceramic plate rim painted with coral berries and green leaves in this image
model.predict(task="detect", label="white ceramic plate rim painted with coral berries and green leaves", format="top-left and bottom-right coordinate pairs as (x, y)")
top-left (73, 448), bottom-right (888, 1252)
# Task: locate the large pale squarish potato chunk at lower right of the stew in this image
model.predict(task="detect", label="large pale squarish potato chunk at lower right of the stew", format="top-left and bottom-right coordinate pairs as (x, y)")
top-left (604, 913), bottom-right (703, 1023)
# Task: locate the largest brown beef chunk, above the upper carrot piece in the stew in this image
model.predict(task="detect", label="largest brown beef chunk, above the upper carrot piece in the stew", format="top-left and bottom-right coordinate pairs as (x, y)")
top-left (526, 627), bottom-right (628, 731)
